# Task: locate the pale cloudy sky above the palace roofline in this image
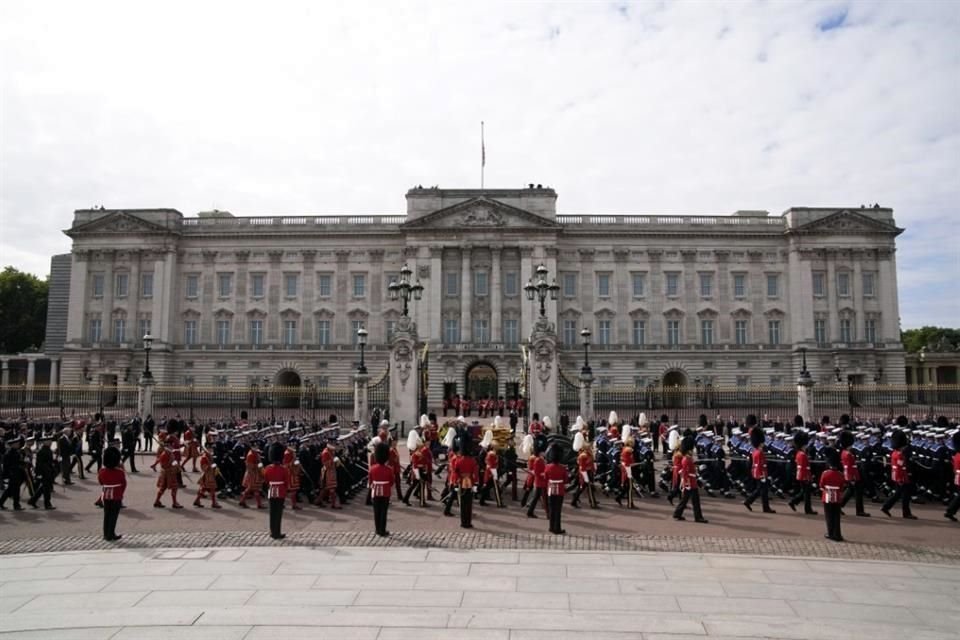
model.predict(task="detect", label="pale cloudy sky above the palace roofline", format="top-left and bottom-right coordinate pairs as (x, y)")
top-left (0, 0), bottom-right (960, 329)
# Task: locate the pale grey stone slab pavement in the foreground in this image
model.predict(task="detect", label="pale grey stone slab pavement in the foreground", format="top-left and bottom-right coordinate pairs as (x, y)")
top-left (0, 547), bottom-right (960, 640)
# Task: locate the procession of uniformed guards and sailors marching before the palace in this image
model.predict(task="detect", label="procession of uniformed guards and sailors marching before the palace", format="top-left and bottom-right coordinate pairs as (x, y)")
top-left (0, 404), bottom-right (960, 541)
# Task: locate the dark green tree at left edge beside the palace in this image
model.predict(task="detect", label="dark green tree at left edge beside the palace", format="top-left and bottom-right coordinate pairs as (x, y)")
top-left (0, 267), bottom-right (48, 353)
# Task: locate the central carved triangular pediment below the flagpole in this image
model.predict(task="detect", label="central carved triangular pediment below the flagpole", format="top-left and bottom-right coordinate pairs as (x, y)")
top-left (400, 196), bottom-right (561, 231)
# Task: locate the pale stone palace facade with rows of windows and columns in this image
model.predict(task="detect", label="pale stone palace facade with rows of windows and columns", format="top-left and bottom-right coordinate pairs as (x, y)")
top-left (59, 186), bottom-right (905, 407)
